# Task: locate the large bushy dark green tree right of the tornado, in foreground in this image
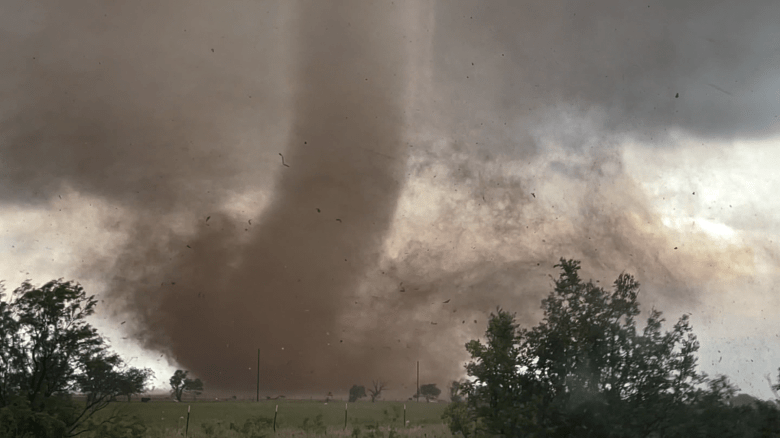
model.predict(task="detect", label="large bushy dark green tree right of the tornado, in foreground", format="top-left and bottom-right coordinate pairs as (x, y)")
top-left (454, 259), bottom-right (705, 436)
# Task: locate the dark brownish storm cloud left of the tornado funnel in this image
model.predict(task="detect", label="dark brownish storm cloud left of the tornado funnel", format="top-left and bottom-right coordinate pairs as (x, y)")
top-left (0, 2), bottom-right (290, 209)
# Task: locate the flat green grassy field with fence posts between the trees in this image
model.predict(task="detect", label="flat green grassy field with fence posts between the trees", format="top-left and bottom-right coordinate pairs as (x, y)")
top-left (100, 400), bottom-right (451, 438)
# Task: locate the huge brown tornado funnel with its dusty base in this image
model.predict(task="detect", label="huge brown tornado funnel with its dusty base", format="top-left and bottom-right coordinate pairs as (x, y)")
top-left (124, 1), bottom-right (418, 391)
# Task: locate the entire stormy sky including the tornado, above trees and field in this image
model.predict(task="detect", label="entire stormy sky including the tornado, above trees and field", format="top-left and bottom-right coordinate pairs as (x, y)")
top-left (0, 0), bottom-right (780, 398)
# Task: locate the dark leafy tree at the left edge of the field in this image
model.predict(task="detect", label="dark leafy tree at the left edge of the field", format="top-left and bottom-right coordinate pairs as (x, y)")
top-left (0, 279), bottom-right (151, 437)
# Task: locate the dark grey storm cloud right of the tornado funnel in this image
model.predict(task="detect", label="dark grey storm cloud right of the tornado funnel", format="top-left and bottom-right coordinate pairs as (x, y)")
top-left (434, 0), bottom-right (780, 149)
